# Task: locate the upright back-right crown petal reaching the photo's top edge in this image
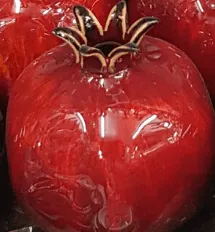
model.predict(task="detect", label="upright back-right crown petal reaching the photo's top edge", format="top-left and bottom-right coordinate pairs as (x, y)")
top-left (104, 0), bottom-right (127, 40)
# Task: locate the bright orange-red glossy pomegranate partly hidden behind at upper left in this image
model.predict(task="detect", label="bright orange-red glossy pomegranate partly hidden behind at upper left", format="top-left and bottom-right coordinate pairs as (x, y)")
top-left (0, 0), bottom-right (116, 96)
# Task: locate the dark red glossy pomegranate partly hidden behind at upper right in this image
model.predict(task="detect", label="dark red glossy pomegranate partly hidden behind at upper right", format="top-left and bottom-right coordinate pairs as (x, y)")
top-left (129, 0), bottom-right (215, 101)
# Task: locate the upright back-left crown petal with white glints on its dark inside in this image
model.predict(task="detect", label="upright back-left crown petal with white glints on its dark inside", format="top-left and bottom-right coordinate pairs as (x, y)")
top-left (73, 5), bottom-right (104, 38)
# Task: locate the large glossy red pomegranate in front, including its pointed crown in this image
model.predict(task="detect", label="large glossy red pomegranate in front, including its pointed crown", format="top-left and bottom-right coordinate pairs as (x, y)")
top-left (7, 1), bottom-right (215, 232)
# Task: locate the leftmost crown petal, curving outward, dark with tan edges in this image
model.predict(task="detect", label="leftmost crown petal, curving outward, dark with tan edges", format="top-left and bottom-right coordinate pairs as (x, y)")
top-left (52, 27), bottom-right (87, 63)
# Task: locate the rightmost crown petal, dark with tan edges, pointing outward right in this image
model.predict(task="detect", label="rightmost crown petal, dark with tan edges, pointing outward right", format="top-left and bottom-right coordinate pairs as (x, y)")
top-left (128, 17), bottom-right (159, 46)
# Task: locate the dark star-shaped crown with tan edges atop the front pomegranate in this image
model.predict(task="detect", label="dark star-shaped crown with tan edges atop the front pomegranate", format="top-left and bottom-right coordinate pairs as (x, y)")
top-left (53, 0), bottom-right (159, 74)
